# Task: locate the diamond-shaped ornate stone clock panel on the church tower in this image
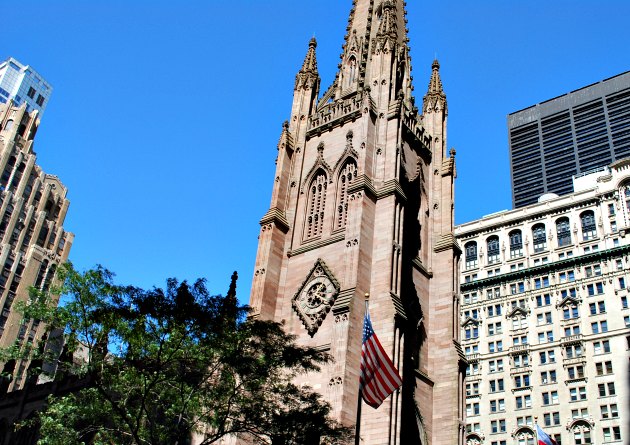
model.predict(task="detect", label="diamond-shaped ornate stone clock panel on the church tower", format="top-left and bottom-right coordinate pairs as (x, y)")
top-left (293, 260), bottom-right (339, 337)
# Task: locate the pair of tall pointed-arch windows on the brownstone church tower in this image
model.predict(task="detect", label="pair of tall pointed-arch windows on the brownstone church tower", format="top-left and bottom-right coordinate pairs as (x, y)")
top-left (304, 158), bottom-right (357, 240)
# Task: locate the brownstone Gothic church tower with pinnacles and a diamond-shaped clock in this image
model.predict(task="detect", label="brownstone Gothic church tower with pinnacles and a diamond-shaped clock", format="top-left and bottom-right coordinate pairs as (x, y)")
top-left (250, 0), bottom-right (465, 445)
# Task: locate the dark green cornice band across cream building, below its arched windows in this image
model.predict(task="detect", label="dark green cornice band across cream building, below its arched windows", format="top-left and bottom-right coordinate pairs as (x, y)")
top-left (460, 245), bottom-right (630, 292)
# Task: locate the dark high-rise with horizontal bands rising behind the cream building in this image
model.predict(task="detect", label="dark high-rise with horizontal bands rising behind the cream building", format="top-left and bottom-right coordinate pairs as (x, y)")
top-left (508, 71), bottom-right (630, 208)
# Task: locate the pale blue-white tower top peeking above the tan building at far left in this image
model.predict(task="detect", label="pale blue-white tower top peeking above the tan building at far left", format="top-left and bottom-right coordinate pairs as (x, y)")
top-left (0, 57), bottom-right (52, 118)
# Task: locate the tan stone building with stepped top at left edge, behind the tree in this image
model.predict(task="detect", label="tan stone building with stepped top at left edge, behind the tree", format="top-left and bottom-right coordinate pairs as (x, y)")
top-left (0, 100), bottom-right (74, 389)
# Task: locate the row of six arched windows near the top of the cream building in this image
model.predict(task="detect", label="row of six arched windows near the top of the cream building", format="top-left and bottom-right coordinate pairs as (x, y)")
top-left (464, 210), bottom-right (597, 269)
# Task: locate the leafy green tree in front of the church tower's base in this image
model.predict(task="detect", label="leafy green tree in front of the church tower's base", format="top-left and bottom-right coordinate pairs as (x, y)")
top-left (16, 265), bottom-right (350, 445)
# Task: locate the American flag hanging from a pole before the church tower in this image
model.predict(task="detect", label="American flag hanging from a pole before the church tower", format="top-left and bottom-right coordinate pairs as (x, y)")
top-left (359, 310), bottom-right (402, 408)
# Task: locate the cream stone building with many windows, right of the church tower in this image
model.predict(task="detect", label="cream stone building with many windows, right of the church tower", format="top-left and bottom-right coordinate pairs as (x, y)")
top-left (455, 159), bottom-right (630, 445)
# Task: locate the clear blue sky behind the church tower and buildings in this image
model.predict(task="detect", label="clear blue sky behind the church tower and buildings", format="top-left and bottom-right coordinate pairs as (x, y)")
top-left (0, 0), bottom-right (630, 302)
